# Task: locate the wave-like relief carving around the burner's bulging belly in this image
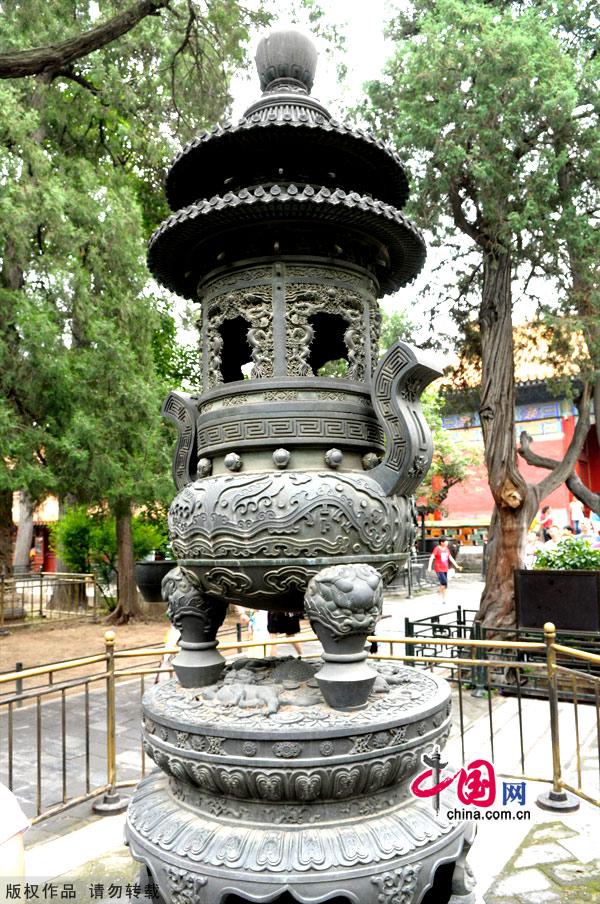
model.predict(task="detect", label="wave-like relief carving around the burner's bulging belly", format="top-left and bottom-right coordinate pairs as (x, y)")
top-left (169, 471), bottom-right (408, 564)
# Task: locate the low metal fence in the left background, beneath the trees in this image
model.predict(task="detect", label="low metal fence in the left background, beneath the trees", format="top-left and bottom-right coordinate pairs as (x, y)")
top-left (0, 571), bottom-right (103, 628)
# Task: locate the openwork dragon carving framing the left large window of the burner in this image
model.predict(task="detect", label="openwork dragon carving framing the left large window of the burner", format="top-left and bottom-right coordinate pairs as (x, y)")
top-left (206, 286), bottom-right (273, 388)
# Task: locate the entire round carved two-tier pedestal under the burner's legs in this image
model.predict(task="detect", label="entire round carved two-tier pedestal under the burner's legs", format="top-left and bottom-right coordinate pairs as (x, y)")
top-left (126, 659), bottom-right (478, 904)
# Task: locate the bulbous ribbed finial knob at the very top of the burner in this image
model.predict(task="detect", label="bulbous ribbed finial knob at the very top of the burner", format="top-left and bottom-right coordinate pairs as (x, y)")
top-left (255, 29), bottom-right (317, 94)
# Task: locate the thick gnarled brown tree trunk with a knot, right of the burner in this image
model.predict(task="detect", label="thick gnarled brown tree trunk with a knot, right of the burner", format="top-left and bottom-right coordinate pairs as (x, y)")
top-left (477, 251), bottom-right (538, 627)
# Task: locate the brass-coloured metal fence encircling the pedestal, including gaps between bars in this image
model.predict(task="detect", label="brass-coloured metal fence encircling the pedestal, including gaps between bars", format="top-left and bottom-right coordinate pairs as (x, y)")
top-left (0, 625), bottom-right (600, 822)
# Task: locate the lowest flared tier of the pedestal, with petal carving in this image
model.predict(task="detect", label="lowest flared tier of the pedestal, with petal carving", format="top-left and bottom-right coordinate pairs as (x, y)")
top-left (126, 772), bottom-right (472, 904)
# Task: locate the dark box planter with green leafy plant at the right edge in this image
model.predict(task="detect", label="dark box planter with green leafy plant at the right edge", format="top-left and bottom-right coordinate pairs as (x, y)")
top-left (515, 537), bottom-right (600, 631)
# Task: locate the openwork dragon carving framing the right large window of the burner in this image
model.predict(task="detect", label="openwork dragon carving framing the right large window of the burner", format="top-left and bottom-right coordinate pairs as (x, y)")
top-left (286, 284), bottom-right (366, 381)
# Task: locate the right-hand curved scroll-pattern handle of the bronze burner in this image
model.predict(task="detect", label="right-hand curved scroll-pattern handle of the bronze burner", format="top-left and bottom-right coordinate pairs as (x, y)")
top-left (369, 342), bottom-right (441, 496)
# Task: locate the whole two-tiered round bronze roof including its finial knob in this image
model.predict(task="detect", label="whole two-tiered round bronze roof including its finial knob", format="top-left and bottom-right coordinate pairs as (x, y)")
top-left (148, 32), bottom-right (425, 298)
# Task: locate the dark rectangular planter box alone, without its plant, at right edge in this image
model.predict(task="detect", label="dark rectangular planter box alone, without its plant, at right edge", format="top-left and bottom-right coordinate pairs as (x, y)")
top-left (515, 569), bottom-right (600, 631)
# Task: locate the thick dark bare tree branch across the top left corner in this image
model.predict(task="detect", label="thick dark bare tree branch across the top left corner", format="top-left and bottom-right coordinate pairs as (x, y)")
top-left (0, 0), bottom-right (170, 78)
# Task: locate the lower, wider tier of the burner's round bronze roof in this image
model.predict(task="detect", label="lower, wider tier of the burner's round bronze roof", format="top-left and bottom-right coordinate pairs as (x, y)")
top-left (148, 183), bottom-right (425, 298)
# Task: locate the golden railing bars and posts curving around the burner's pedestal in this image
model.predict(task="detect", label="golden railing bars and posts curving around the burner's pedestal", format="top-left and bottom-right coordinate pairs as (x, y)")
top-left (0, 624), bottom-right (600, 822)
